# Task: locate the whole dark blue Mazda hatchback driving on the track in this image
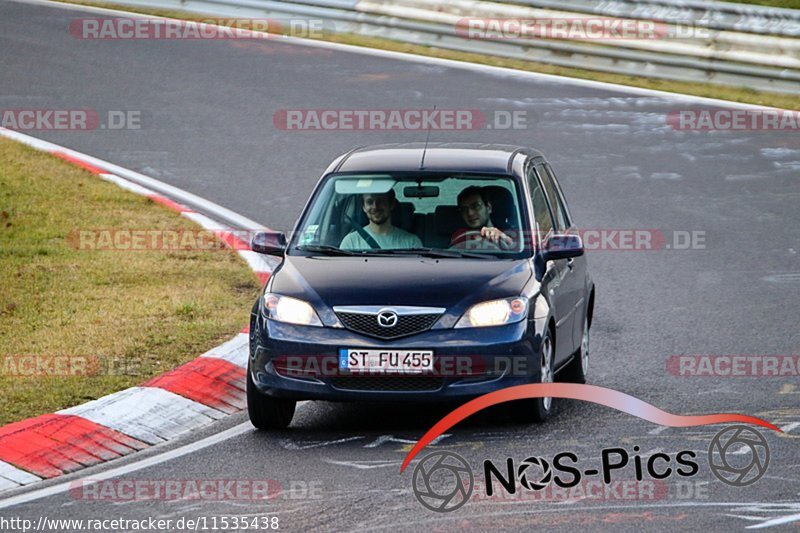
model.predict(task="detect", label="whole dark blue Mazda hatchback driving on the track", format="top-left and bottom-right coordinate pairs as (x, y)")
top-left (247, 144), bottom-right (594, 429)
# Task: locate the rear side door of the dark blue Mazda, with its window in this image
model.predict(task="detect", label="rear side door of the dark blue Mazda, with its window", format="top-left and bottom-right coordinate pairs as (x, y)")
top-left (536, 164), bottom-right (586, 351)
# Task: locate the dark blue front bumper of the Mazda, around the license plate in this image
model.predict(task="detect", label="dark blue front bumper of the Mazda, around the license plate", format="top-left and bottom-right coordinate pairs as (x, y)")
top-left (248, 314), bottom-right (545, 401)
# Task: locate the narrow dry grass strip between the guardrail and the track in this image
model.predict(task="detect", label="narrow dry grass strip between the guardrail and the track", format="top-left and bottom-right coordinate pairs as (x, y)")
top-left (57, 0), bottom-right (800, 110)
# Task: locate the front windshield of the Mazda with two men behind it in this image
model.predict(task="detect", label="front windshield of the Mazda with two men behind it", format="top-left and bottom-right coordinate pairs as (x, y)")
top-left (290, 173), bottom-right (525, 259)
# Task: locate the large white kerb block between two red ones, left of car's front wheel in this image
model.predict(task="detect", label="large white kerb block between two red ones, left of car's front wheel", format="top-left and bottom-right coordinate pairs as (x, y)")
top-left (58, 387), bottom-right (225, 444)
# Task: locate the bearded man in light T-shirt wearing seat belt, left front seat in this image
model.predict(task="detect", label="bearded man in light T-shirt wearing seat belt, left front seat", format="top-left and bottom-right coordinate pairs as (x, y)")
top-left (339, 189), bottom-right (422, 250)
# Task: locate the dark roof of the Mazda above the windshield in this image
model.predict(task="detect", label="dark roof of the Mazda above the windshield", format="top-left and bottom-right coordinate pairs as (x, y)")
top-left (329, 142), bottom-right (544, 174)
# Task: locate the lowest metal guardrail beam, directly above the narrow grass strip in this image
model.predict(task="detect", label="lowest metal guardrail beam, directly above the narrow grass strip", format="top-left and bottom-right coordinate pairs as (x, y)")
top-left (89, 0), bottom-right (800, 94)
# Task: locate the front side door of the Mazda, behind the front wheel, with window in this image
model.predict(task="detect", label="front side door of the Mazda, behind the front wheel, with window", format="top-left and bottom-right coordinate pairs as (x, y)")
top-left (525, 163), bottom-right (574, 365)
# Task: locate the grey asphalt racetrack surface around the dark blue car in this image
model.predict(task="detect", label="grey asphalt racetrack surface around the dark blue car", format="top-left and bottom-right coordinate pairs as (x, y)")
top-left (0, 1), bottom-right (800, 531)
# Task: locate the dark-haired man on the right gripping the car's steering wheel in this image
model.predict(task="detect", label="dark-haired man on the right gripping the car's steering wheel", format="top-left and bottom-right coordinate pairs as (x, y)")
top-left (450, 185), bottom-right (514, 249)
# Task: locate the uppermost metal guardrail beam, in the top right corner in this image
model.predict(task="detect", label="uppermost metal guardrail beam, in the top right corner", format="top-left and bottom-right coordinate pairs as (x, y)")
top-left (514, 0), bottom-right (800, 37)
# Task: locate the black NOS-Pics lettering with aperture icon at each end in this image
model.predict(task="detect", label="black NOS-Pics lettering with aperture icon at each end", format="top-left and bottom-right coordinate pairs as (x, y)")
top-left (412, 425), bottom-right (770, 513)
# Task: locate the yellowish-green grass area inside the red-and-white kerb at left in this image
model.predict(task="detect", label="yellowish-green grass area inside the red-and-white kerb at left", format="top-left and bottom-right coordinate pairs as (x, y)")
top-left (0, 139), bottom-right (259, 424)
